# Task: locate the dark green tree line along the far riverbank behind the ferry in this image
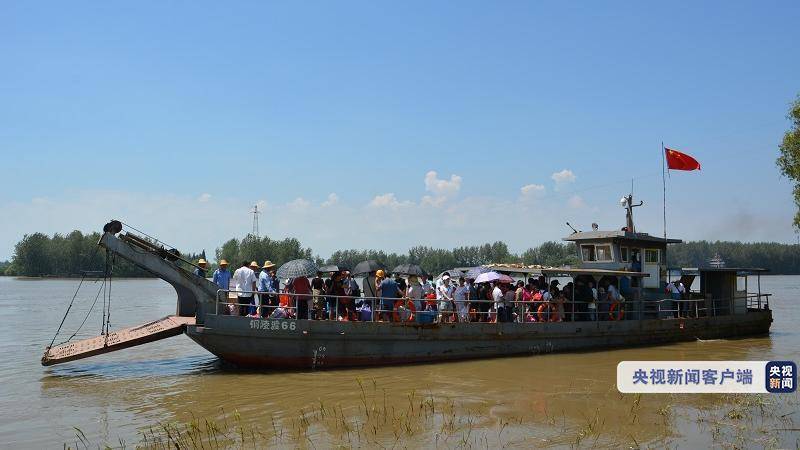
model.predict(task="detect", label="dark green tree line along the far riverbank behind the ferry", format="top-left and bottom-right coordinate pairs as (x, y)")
top-left (6, 230), bottom-right (800, 277)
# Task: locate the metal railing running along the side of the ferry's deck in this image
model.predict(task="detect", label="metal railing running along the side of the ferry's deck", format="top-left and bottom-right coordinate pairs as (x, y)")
top-left (213, 289), bottom-right (771, 323)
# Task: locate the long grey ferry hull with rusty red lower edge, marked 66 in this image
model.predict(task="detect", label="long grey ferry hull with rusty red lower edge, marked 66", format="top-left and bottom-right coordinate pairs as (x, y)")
top-left (186, 310), bottom-right (772, 369)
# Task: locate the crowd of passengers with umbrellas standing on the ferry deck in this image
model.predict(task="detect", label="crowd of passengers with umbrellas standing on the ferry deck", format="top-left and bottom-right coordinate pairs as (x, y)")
top-left (200, 259), bottom-right (625, 323)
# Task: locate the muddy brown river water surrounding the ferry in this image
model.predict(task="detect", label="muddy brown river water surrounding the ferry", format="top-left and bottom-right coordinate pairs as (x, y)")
top-left (0, 276), bottom-right (800, 448)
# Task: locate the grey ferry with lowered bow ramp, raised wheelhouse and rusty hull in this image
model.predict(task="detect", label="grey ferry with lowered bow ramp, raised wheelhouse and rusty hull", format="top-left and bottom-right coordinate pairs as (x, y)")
top-left (42, 196), bottom-right (772, 369)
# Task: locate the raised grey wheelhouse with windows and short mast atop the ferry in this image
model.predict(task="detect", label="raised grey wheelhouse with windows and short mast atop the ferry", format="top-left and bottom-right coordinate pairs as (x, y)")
top-left (564, 195), bottom-right (682, 289)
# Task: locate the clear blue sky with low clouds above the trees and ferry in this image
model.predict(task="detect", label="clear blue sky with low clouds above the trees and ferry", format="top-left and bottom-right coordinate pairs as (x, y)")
top-left (0, 1), bottom-right (800, 259)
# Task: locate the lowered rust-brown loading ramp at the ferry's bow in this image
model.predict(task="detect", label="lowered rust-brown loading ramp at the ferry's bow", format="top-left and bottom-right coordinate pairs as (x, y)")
top-left (42, 316), bottom-right (195, 366)
